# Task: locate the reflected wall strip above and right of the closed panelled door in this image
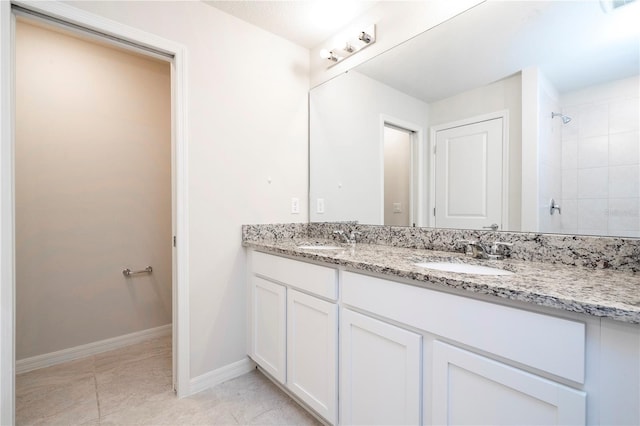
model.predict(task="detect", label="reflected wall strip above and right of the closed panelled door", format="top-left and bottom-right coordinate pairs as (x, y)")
top-left (429, 74), bottom-right (522, 231)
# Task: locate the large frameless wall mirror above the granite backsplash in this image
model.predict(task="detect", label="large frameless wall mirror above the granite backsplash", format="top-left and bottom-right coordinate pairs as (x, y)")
top-left (309, 0), bottom-right (640, 237)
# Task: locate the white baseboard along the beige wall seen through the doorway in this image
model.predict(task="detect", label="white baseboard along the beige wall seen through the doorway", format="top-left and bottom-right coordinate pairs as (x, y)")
top-left (16, 324), bottom-right (171, 374)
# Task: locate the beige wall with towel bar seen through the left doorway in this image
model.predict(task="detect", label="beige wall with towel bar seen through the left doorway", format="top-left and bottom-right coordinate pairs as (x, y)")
top-left (15, 21), bottom-right (171, 359)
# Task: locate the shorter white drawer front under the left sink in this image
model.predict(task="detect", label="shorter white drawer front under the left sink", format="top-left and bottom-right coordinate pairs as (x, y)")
top-left (251, 252), bottom-right (338, 300)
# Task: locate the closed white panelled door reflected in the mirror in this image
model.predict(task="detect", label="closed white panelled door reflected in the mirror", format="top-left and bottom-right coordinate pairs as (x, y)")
top-left (435, 118), bottom-right (503, 229)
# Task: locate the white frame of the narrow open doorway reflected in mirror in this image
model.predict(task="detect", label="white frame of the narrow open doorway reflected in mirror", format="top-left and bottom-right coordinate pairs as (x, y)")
top-left (379, 114), bottom-right (428, 226)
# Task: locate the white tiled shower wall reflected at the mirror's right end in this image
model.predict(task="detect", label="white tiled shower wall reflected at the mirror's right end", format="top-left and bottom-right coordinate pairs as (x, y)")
top-left (560, 76), bottom-right (640, 237)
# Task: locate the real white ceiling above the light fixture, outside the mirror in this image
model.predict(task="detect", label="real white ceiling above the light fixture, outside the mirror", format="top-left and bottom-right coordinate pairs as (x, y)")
top-left (204, 0), bottom-right (379, 49)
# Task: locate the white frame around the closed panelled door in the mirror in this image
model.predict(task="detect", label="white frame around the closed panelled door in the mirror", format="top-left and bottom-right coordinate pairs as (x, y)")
top-left (428, 109), bottom-right (509, 231)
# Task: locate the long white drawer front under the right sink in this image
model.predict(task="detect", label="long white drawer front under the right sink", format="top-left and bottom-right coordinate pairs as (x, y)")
top-left (341, 272), bottom-right (586, 383)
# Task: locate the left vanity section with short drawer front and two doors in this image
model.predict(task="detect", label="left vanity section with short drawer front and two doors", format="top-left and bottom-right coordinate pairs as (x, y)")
top-left (249, 252), bottom-right (338, 424)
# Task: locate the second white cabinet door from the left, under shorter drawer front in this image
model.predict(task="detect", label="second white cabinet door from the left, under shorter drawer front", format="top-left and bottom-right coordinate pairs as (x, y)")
top-left (287, 289), bottom-right (338, 424)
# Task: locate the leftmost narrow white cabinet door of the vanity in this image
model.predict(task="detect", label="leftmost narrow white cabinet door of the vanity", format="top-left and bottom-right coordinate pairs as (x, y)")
top-left (251, 276), bottom-right (287, 383)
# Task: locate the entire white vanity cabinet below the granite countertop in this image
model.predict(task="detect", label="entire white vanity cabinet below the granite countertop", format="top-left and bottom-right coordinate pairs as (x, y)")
top-left (249, 250), bottom-right (640, 426)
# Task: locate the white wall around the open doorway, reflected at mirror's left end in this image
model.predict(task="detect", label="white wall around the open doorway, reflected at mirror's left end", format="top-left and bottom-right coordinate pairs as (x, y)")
top-left (309, 71), bottom-right (428, 225)
